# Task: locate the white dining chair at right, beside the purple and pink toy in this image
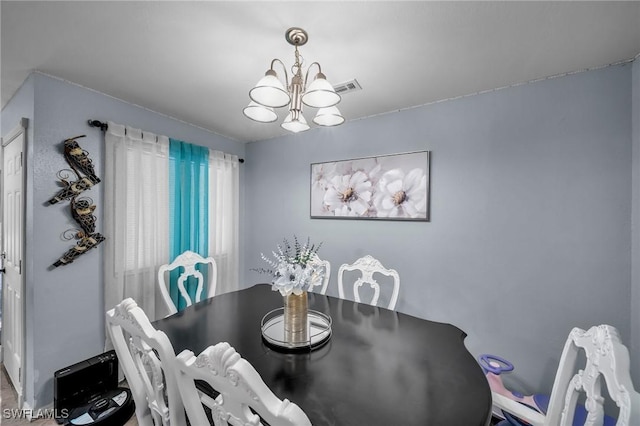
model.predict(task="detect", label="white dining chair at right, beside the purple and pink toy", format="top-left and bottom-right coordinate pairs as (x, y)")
top-left (492, 325), bottom-right (640, 426)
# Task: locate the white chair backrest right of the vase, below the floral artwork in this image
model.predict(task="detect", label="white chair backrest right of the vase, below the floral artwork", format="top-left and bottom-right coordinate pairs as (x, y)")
top-left (338, 255), bottom-right (400, 310)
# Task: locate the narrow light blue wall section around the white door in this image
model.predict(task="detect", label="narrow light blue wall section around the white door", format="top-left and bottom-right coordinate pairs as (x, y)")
top-left (0, 76), bottom-right (35, 401)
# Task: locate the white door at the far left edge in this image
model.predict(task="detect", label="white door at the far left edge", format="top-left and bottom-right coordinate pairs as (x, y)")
top-left (2, 119), bottom-right (26, 404)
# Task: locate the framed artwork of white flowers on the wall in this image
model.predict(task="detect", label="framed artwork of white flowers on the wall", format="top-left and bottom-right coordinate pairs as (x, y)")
top-left (311, 151), bottom-right (430, 221)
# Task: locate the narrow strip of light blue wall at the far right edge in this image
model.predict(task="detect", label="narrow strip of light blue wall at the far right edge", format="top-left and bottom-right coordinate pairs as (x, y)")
top-left (631, 58), bottom-right (640, 389)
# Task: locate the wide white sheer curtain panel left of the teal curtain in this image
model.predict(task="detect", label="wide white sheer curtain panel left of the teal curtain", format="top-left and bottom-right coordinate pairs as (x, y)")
top-left (104, 122), bottom-right (169, 319)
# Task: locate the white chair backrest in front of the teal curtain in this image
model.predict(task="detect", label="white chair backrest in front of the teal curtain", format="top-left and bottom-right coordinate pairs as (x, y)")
top-left (158, 250), bottom-right (218, 315)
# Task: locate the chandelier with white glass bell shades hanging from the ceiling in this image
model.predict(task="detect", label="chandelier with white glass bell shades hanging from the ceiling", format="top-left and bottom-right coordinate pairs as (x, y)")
top-left (242, 27), bottom-right (344, 133)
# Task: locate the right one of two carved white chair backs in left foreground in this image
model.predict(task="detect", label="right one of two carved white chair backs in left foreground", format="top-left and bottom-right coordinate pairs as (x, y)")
top-left (176, 342), bottom-right (311, 426)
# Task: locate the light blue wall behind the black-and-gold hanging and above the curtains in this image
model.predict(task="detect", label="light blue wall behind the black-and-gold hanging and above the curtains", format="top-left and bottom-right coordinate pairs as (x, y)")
top-left (3, 74), bottom-right (245, 407)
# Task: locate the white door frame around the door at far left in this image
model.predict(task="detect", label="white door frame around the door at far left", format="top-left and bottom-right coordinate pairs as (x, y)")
top-left (0, 118), bottom-right (29, 408)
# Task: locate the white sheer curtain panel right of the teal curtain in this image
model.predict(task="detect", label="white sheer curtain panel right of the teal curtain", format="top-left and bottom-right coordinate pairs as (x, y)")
top-left (209, 150), bottom-right (240, 293)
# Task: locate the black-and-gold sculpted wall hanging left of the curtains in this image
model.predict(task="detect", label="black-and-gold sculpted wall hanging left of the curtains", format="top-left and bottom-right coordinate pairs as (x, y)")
top-left (49, 135), bottom-right (105, 267)
